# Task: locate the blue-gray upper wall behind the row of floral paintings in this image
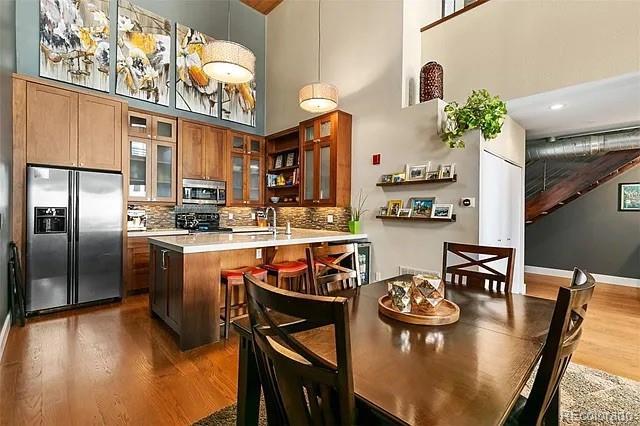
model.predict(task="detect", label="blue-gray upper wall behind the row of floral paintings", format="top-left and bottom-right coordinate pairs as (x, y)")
top-left (15, 0), bottom-right (266, 134)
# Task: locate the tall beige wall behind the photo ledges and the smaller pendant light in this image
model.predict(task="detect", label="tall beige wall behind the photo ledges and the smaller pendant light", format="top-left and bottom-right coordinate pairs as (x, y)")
top-left (267, 0), bottom-right (479, 276)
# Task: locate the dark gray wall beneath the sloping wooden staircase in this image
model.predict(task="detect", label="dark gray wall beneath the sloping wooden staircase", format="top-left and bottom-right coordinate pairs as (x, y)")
top-left (525, 167), bottom-right (640, 278)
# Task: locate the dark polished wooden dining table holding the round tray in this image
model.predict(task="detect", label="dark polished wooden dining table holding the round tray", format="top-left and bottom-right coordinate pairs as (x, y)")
top-left (233, 275), bottom-right (554, 426)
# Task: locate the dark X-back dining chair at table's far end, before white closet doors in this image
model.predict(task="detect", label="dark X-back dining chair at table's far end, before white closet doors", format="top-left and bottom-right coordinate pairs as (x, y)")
top-left (442, 242), bottom-right (515, 293)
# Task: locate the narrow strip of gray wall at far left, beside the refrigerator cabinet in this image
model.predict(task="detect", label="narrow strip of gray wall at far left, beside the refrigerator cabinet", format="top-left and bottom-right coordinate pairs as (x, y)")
top-left (0, 0), bottom-right (16, 322)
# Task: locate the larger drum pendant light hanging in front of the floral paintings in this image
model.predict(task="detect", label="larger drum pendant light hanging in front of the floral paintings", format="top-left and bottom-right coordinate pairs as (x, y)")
top-left (202, 0), bottom-right (256, 83)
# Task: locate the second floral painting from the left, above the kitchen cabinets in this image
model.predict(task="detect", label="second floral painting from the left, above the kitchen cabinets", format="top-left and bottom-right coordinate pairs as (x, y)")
top-left (116, 0), bottom-right (171, 106)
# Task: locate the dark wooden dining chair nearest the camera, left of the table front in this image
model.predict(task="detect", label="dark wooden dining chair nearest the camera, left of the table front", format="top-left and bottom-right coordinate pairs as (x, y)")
top-left (244, 274), bottom-right (355, 425)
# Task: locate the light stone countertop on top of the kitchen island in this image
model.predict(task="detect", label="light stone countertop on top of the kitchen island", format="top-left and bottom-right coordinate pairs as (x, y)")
top-left (149, 228), bottom-right (367, 253)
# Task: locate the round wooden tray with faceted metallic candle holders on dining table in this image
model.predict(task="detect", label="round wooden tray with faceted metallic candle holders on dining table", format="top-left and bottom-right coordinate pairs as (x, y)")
top-left (378, 274), bottom-right (460, 325)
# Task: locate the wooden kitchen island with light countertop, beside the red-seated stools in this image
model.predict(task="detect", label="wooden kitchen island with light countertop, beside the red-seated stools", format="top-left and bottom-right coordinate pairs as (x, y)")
top-left (148, 229), bottom-right (367, 350)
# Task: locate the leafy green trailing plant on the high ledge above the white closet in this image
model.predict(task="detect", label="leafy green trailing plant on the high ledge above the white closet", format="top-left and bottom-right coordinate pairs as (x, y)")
top-left (442, 89), bottom-right (507, 148)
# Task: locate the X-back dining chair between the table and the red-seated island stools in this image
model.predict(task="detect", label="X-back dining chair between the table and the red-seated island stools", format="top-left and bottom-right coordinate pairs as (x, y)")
top-left (307, 243), bottom-right (362, 296)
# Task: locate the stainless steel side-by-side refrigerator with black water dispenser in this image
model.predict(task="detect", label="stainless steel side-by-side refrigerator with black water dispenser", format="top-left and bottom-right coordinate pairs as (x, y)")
top-left (25, 166), bottom-right (123, 313)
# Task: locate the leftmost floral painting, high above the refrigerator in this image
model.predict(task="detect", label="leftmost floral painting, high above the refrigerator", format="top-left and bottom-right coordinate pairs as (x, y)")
top-left (40, 0), bottom-right (109, 92)
